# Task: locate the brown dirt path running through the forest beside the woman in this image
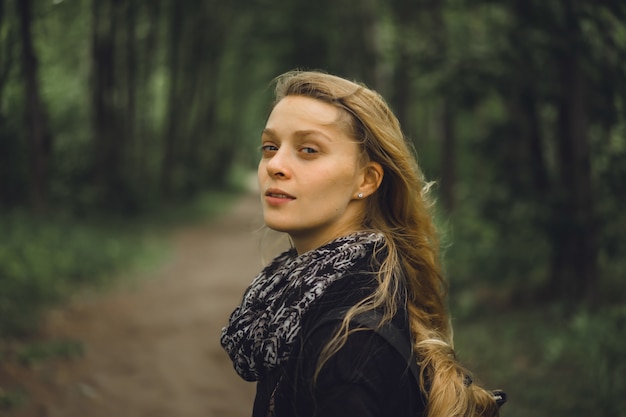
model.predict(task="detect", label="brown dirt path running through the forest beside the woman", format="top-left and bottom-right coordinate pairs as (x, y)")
top-left (0, 195), bottom-right (274, 417)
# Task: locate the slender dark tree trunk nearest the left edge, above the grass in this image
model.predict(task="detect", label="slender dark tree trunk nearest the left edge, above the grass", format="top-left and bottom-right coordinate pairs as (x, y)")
top-left (17, 0), bottom-right (52, 212)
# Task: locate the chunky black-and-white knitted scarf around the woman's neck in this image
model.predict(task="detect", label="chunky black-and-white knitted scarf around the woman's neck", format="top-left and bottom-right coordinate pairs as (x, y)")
top-left (221, 232), bottom-right (383, 381)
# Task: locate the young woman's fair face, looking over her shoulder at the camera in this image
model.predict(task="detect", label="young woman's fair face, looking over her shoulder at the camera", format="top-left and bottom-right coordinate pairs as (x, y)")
top-left (258, 96), bottom-right (364, 253)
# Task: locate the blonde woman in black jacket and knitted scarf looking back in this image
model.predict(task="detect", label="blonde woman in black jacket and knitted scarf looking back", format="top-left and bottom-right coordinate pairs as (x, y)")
top-left (221, 71), bottom-right (498, 417)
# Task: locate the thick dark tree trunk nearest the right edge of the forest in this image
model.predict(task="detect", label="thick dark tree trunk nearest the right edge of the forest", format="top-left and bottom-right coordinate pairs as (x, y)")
top-left (550, 1), bottom-right (598, 304)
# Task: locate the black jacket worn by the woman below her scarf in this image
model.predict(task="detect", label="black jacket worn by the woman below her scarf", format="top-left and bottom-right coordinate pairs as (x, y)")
top-left (252, 274), bottom-right (424, 417)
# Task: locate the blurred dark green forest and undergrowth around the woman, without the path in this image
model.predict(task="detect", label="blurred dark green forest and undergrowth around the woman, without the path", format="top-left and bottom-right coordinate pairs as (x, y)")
top-left (0, 0), bottom-right (626, 416)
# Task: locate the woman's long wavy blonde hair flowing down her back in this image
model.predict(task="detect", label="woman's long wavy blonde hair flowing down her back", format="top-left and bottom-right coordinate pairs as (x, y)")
top-left (275, 71), bottom-right (498, 417)
